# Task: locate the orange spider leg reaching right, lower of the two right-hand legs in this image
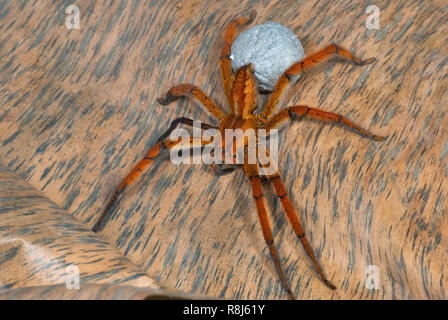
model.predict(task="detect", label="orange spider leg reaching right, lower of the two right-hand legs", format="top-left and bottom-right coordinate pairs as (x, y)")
top-left (265, 106), bottom-right (386, 141)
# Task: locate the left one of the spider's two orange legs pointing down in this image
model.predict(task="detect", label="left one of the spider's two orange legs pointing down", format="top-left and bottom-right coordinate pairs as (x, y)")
top-left (244, 164), bottom-right (295, 300)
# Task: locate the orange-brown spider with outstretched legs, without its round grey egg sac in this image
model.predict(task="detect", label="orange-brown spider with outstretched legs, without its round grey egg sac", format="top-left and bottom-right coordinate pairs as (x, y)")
top-left (93, 11), bottom-right (385, 299)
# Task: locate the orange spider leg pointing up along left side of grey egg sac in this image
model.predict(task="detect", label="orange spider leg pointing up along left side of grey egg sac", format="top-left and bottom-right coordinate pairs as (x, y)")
top-left (219, 11), bottom-right (257, 114)
